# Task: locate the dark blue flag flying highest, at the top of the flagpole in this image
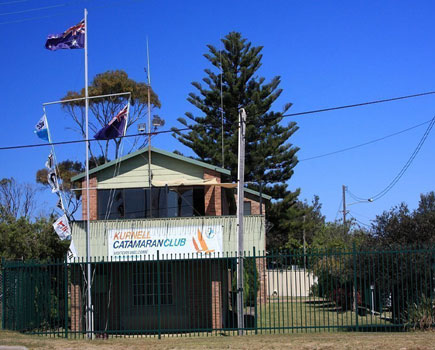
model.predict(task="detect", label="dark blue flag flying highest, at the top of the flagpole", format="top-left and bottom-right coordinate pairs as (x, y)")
top-left (45, 19), bottom-right (85, 51)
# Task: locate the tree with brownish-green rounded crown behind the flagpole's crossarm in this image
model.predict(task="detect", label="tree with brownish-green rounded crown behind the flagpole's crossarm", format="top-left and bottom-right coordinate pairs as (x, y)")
top-left (62, 70), bottom-right (160, 162)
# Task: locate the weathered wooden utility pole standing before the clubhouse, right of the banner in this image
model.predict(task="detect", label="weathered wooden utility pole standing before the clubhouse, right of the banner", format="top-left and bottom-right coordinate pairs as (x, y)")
top-left (237, 108), bottom-right (246, 335)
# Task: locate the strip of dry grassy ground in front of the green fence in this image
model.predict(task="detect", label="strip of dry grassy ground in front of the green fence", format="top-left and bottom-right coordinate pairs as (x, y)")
top-left (0, 331), bottom-right (435, 350)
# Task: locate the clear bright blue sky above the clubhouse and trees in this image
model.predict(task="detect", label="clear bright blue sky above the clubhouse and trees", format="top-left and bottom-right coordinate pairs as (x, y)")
top-left (0, 0), bottom-right (435, 223)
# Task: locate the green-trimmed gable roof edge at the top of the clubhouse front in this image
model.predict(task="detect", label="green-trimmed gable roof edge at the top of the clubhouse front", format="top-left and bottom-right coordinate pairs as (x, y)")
top-left (71, 147), bottom-right (231, 182)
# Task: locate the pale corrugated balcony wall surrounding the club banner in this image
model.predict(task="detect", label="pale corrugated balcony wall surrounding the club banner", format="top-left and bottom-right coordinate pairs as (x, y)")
top-left (71, 215), bottom-right (265, 257)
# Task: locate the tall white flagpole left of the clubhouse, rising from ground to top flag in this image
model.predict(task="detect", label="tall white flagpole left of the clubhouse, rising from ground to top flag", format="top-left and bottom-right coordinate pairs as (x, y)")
top-left (84, 9), bottom-right (93, 339)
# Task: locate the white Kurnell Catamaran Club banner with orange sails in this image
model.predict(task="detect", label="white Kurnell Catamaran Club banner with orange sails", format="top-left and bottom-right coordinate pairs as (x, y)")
top-left (107, 225), bottom-right (223, 259)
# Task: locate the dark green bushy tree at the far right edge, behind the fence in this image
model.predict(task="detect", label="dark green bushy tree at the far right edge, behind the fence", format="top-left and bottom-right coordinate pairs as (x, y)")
top-left (358, 191), bottom-right (435, 324)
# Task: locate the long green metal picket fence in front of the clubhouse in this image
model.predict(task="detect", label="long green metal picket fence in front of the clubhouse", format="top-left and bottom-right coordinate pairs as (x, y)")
top-left (1, 248), bottom-right (435, 337)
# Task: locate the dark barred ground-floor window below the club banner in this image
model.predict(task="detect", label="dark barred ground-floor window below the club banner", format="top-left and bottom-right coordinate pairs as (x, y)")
top-left (133, 263), bottom-right (173, 305)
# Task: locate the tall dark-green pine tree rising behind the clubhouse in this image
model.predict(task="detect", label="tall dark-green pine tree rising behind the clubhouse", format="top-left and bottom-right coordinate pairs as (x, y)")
top-left (174, 32), bottom-right (298, 247)
